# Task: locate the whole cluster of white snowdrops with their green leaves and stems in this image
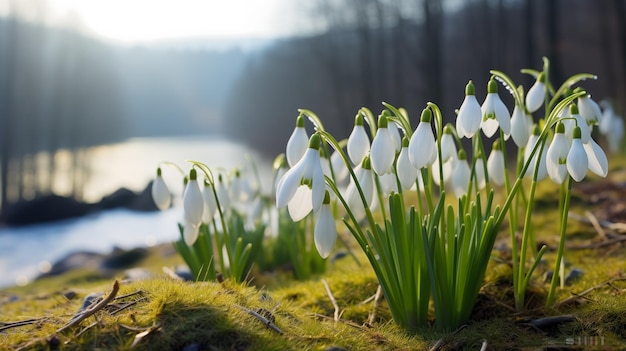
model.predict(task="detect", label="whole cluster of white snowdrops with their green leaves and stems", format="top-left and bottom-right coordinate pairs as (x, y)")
top-left (153, 59), bottom-right (624, 332)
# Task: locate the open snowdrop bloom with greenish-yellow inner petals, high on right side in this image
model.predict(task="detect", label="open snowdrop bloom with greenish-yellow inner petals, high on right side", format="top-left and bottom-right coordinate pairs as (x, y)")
top-left (480, 78), bottom-right (511, 138)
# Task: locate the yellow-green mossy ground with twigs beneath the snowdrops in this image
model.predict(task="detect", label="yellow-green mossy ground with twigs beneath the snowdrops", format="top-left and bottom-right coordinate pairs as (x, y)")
top-left (0, 161), bottom-right (626, 350)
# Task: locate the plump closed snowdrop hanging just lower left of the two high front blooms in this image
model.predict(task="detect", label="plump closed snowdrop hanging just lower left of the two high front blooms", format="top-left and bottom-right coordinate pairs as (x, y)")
top-left (409, 108), bottom-right (437, 169)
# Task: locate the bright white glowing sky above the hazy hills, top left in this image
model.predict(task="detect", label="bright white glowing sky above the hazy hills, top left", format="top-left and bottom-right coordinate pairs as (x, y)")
top-left (0, 0), bottom-right (297, 43)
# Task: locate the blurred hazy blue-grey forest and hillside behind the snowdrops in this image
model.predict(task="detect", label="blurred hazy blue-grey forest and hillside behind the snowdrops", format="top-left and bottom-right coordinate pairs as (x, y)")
top-left (0, 0), bottom-right (626, 219)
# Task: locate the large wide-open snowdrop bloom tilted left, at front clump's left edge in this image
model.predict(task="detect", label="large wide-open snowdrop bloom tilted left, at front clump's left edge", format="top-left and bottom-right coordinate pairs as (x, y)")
top-left (276, 134), bottom-right (325, 222)
